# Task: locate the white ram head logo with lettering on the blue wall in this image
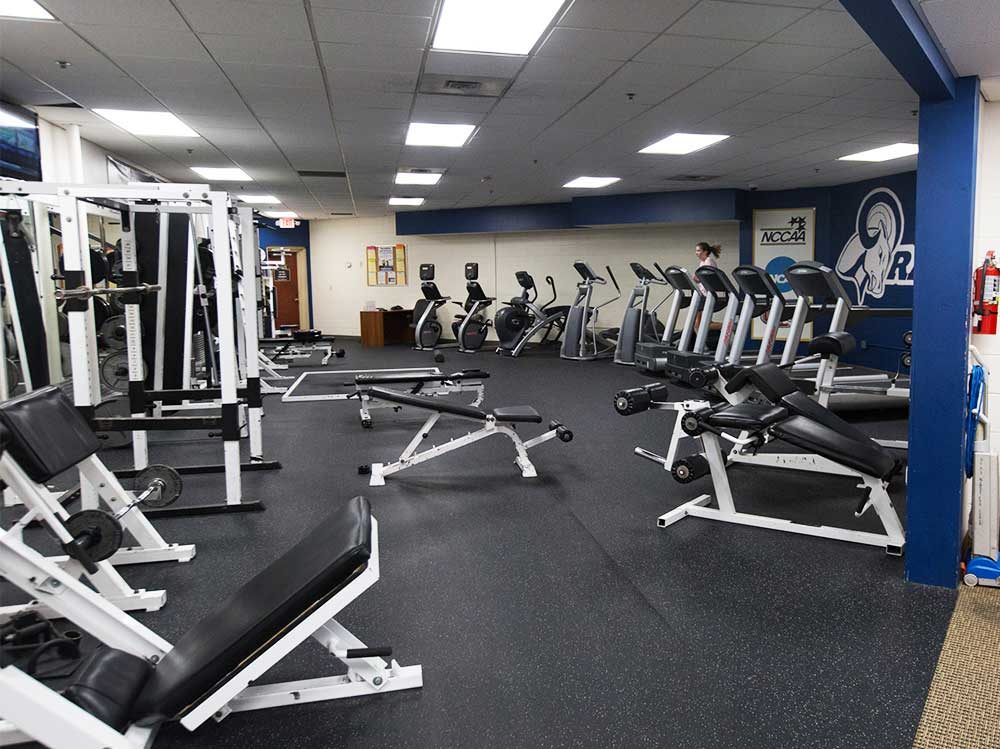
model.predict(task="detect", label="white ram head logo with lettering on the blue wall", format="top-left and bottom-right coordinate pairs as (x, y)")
top-left (837, 187), bottom-right (914, 304)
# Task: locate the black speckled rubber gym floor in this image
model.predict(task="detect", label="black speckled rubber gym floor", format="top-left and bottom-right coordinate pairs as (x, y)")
top-left (0, 342), bottom-right (955, 748)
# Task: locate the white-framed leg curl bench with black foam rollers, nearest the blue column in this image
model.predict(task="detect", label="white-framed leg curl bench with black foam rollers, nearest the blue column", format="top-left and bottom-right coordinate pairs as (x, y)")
top-left (615, 363), bottom-right (905, 555)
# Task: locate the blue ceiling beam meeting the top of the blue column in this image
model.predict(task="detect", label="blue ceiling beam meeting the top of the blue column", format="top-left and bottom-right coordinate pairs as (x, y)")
top-left (840, 0), bottom-right (955, 101)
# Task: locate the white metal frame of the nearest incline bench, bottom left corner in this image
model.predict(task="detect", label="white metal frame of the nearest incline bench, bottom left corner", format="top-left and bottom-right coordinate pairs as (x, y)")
top-left (0, 518), bottom-right (423, 749)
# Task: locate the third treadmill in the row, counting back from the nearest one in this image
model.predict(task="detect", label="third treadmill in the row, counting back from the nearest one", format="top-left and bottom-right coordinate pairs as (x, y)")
top-left (665, 265), bottom-right (749, 387)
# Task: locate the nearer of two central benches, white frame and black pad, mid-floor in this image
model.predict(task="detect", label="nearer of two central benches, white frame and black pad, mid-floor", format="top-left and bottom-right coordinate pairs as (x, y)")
top-left (358, 386), bottom-right (573, 486)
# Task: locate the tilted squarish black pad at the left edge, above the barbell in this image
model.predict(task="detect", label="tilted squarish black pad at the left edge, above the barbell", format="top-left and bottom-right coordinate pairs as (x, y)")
top-left (0, 386), bottom-right (101, 484)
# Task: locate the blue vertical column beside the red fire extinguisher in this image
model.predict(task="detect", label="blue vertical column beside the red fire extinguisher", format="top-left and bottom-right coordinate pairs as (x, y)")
top-left (906, 77), bottom-right (979, 587)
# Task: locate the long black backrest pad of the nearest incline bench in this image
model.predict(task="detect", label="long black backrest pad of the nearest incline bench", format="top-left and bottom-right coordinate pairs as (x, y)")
top-left (132, 497), bottom-right (371, 725)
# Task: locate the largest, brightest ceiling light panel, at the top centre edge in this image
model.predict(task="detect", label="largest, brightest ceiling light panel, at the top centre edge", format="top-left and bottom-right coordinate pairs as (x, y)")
top-left (432, 0), bottom-right (564, 55)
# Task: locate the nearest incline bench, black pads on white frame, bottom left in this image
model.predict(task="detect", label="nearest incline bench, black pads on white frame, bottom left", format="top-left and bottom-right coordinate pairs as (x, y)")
top-left (0, 497), bottom-right (423, 749)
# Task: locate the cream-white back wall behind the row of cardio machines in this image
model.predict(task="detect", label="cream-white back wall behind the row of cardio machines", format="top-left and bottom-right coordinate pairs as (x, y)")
top-left (309, 216), bottom-right (739, 335)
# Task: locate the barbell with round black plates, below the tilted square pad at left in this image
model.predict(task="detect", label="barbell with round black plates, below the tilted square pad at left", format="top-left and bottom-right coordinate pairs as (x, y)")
top-left (63, 464), bottom-right (183, 573)
